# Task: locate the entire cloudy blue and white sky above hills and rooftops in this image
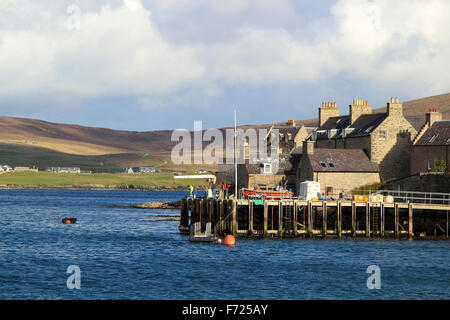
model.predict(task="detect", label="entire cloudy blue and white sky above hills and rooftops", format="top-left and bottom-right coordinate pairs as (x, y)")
top-left (0, 0), bottom-right (450, 131)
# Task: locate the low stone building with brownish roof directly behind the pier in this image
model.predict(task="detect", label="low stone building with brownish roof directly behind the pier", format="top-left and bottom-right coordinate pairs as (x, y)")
top-left (296, 141), bottom-right (380, 195)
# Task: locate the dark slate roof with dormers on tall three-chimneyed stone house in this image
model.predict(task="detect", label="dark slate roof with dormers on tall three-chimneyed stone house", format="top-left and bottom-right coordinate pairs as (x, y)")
top-left (317, 113), bottom-right (388, 140)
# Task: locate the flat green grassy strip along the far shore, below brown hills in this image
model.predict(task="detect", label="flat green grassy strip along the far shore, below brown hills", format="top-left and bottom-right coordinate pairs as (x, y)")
top-left (0, 171), bottom-right (207, 188)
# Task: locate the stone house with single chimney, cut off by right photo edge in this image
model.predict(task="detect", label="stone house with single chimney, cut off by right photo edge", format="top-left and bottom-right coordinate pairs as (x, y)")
top-left (411, 109), bottom-right (450, 175)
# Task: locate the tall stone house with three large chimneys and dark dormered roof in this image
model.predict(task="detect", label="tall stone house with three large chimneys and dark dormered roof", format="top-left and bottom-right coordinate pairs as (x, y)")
top-left (311, 98), bottom-right (417, 180)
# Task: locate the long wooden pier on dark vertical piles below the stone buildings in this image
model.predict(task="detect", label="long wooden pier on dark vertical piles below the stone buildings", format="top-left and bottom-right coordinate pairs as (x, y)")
top-left (180, 198), bottom-right (450, 239)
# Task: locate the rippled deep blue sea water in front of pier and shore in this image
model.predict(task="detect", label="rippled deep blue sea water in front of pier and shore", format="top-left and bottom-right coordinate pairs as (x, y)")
top-left (0, 190), bottom-right (450, 299)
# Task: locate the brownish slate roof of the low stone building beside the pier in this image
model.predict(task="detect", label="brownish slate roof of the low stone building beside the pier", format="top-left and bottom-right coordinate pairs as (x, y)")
top-left (308, 148), bottom-right (380, 172)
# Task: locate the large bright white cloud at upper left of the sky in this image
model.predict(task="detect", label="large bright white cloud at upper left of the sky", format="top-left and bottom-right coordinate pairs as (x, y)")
top-left (0, 0), bottom-right (203, 97)
